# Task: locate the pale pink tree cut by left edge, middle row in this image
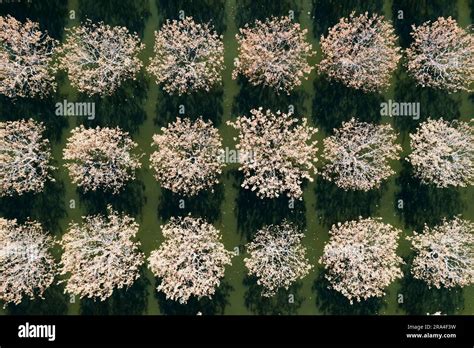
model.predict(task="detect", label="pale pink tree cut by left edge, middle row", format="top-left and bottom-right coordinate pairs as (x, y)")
top-left (0, 119), bottom-right (55, 196)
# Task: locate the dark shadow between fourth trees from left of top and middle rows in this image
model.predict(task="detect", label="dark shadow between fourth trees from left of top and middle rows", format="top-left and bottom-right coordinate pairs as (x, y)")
top-left (232, 76), bottom-right (309, 117)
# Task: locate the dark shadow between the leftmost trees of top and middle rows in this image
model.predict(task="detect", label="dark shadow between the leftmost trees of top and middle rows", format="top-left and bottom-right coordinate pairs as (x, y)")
top-left (0, 88), bottom-right (68, 142)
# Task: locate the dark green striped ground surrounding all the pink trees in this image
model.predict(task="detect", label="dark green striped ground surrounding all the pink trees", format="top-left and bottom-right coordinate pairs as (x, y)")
top-left (0, 0), bottom-right (474, 315)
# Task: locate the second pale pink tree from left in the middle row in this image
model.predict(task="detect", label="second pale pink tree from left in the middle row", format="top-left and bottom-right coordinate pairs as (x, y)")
top-left (63, 125), bottom-right (141, 193)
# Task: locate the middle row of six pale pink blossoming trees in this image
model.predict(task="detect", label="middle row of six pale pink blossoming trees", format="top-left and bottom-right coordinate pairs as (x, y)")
top-left (0, 115), bottom-right (474, 199)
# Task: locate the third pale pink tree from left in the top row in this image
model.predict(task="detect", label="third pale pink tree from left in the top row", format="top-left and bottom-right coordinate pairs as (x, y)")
top-left (147, 17), bottom-right (224, 95)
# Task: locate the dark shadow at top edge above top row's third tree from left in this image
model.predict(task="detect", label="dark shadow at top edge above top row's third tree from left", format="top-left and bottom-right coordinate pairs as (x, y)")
top-left (156, 0), bottom-right (226, 34)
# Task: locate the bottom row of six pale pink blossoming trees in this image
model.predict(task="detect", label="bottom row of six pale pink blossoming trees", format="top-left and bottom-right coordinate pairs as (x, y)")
top-left (0, 212), bottom-right (474, 305)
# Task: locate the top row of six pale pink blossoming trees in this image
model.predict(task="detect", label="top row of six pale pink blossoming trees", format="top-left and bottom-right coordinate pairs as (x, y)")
top-left (0, 13), bottom-right (474, 98)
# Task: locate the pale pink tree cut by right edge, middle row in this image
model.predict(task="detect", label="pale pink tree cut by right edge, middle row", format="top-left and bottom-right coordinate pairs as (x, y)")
top-left (408, 118), bottom-right (474, 187)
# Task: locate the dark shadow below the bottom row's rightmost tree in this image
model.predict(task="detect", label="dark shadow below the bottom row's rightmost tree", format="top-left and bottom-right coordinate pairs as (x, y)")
top-left (399, 254), bottom-right (464, 315)
